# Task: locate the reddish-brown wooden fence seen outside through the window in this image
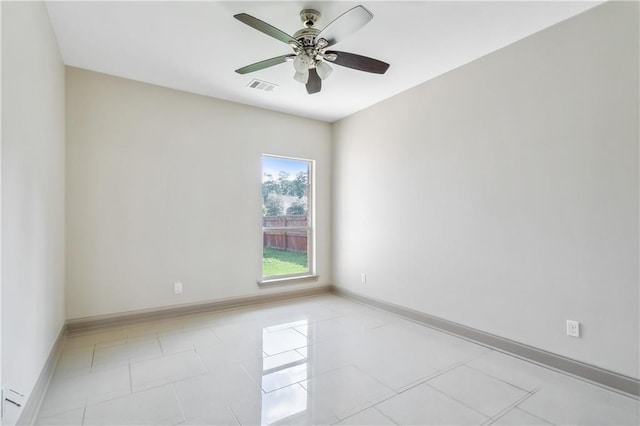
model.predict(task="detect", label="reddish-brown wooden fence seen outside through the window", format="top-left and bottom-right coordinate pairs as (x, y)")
top-left (262, 215), bottom-right (307, 253)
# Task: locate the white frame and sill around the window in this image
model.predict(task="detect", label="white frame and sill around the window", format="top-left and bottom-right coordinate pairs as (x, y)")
top-left (258, 153), bottom-right (318, 285)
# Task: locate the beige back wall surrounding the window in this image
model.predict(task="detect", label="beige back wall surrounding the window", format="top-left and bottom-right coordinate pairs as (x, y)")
top-left (67, 68), bottom-right (331, 318)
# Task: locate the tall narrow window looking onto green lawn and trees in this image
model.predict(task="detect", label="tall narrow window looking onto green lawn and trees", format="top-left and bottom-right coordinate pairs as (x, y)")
top-left (262, 155), bottom-right (314, 282)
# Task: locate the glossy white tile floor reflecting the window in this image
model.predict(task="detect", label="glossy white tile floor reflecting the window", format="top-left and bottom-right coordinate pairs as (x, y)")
top-left (37, 295), bottom-right (640, 425)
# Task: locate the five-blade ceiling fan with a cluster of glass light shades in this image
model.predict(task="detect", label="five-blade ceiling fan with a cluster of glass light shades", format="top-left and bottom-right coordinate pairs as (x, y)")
top-left (233, 6), bottom-right (389, 94)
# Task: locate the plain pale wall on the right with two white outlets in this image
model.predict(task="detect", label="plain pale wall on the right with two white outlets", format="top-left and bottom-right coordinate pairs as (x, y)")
top-left (333, 2), bottom-right (640, 378)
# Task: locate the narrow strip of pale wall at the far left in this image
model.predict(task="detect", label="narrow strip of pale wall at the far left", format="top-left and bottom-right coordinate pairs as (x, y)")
top-left (1, 2), bottom-right (65, 424)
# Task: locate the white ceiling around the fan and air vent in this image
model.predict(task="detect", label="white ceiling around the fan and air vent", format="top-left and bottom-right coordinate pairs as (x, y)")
top-left (47, 1), bottom-right (602, 122)
